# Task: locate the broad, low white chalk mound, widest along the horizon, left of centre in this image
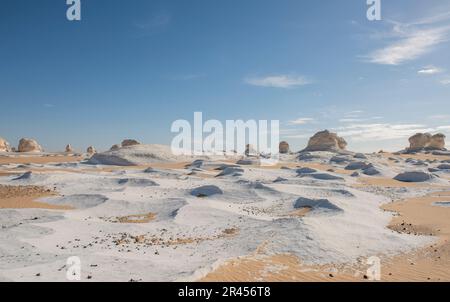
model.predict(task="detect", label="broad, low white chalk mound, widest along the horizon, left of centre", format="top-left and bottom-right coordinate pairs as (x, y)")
top-left (88, 145), bottom-right (192, 166)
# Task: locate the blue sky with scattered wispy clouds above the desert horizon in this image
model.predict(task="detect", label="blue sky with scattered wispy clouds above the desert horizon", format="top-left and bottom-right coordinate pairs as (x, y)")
top-left (0, 0), bottom-right (450, 152)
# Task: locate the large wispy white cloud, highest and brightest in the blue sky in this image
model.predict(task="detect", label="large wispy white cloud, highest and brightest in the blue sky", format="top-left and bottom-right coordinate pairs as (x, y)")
top-left (367, 24), bottom-right (449, 65)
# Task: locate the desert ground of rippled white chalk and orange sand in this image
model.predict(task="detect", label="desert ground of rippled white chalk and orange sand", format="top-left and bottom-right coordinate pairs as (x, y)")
top-left (0, 150), bottom-right (450, 282)
